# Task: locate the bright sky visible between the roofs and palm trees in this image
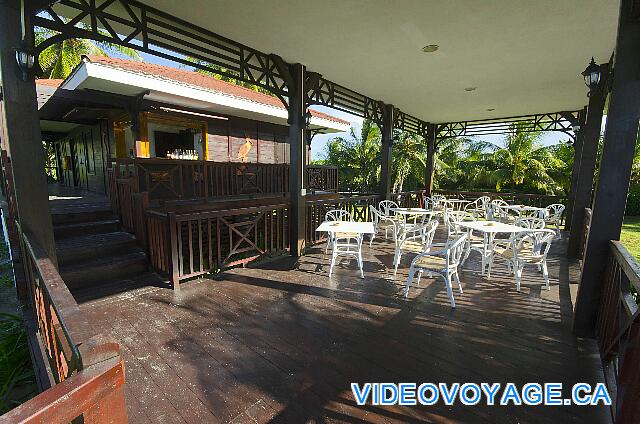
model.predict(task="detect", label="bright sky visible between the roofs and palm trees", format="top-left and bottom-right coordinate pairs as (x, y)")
top-left (132, 52), bottom-right (568, 160)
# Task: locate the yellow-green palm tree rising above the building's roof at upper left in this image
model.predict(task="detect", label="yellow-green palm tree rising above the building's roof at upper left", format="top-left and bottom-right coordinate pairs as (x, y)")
top-left (35, 28), bottom-right (142, 78)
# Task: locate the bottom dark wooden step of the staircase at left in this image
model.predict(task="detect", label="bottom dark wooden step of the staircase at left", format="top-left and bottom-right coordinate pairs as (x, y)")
top-left (60, 251), bottom-right (148, 289)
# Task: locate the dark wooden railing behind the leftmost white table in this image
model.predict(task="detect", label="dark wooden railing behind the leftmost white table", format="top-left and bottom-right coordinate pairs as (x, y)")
top-left (305, 194), bottom-right (381, 245)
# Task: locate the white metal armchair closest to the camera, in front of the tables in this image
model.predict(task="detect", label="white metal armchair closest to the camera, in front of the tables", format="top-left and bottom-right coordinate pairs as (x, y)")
top-left (404, 234), bottom-right (467, 308)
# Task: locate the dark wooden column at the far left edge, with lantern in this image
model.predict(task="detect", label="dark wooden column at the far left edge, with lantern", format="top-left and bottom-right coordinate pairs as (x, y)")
top-left (0, 0), bottom-right (57, 264)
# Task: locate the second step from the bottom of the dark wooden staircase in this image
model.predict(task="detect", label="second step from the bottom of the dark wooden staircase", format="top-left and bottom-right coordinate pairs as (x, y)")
top-left (56, 231), bottom-right (140, 266)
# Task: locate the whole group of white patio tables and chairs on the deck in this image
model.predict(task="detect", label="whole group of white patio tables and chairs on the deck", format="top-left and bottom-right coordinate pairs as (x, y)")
top-left (316, 196), bottom-right (565, 307)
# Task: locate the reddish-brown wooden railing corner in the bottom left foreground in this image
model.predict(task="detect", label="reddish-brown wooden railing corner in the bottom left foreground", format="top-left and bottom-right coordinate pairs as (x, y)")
top-left (0, 224), bottom-right (127, 423)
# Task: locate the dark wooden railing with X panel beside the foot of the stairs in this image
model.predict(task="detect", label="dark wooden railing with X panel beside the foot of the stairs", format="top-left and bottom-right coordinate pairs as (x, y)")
top-left (147, 203), bottom-right (289, 288)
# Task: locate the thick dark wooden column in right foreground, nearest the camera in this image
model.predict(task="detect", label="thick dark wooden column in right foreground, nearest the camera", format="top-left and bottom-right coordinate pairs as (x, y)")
top-left (573, 0), bottom-right (640, 337)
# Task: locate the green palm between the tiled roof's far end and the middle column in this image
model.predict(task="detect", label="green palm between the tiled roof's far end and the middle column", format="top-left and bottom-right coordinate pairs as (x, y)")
top-left (318, 120), bottom-right (381, 192)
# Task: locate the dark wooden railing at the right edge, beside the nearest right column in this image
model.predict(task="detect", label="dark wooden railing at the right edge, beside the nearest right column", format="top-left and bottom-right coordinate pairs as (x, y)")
top-left (596, 241), bottom-right (640, 424)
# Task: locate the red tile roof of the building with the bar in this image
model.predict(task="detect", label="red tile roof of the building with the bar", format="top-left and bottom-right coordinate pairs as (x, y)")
top-left (69, 56), bottom-right (350, 125)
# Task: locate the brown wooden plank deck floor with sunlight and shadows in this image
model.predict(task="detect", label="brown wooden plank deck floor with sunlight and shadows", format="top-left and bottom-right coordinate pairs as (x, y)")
top-left (81, 234), bottom-right (608, 423)
